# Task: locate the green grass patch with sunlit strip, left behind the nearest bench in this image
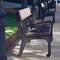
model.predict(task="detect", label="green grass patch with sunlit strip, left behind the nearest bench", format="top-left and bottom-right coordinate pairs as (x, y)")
top-left (5, 14), bottom-right (17, 38)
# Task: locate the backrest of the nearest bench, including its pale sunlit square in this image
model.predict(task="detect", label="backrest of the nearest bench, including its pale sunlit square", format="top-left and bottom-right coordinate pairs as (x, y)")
top-left (16, 7), bottom-right (31, 36)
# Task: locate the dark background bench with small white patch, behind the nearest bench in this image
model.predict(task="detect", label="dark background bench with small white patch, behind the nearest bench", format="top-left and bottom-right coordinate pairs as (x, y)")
top-left (38, 0), bottom-right (56, 23)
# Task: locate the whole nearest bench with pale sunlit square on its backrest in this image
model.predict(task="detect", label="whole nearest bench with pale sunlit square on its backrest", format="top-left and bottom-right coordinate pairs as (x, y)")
top-left (16, 7), bottom-right (53, 57)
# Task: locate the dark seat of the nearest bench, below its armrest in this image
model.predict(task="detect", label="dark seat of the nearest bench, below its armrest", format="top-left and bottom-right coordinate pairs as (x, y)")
top-left (26, 25), bottom-right (51, 37)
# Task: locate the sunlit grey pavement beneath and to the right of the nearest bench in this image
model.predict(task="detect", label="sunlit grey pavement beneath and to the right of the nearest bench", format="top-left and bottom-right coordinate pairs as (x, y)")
top-left (7, 4), bottom-right (60, 60)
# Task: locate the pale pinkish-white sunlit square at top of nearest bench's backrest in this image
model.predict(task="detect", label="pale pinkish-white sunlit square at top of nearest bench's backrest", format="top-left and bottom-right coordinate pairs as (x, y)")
top-left (19, 7), bottom-right (31, 20)
